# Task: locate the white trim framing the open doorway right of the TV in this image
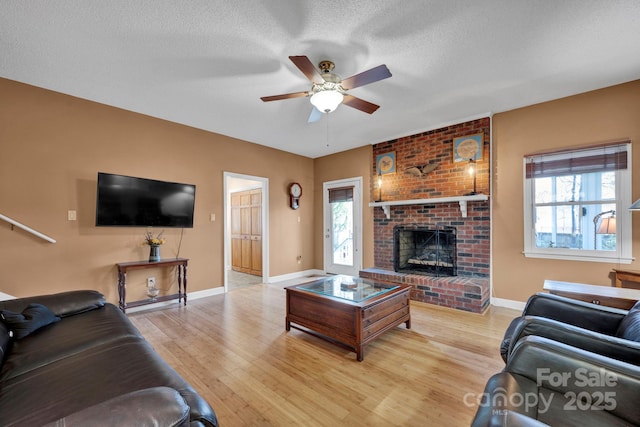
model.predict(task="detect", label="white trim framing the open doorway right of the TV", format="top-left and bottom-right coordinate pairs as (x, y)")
top-left (222, 171), bottom-right (269, 292)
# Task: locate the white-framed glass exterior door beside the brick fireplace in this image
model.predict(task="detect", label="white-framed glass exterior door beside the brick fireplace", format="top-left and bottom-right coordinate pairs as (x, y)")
top-left (323, 177), bottom-right (362, 277)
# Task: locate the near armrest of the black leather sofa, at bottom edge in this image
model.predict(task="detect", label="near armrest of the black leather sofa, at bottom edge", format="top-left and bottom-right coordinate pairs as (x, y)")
top-left (46, 387), bottom-right (189, 427)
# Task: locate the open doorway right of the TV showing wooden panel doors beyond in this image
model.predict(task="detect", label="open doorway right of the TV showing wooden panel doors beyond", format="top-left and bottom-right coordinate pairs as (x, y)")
top-left (224, 172), bottom-right (269, 292)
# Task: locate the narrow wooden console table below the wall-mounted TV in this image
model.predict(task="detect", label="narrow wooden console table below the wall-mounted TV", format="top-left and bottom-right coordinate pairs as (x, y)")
top-left (116, 258), bottom-right (189, 313)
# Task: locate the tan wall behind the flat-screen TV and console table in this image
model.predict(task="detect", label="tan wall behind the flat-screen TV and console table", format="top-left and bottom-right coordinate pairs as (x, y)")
top-left (0, 79), bottom-right (316, 302)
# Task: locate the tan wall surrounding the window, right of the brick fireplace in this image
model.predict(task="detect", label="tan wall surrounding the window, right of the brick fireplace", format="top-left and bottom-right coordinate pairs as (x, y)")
top-left (492, 81), bottom-right (640, 301)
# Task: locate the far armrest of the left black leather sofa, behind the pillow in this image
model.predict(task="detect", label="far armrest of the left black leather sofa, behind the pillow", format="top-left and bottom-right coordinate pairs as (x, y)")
top-left (0, 290), bottom-right (106, 317)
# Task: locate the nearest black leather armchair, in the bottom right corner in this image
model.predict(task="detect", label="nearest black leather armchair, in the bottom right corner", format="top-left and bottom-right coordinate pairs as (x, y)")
top-left (471, 336), bottom-right (640, 427)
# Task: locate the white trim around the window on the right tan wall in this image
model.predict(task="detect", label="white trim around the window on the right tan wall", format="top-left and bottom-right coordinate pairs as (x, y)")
top-left (522, 144), bottom-right (635, 264)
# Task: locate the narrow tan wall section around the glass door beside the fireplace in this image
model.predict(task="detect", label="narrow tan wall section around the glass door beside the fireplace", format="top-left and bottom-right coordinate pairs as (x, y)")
top-left (314, 145), bottom-right (374, 269)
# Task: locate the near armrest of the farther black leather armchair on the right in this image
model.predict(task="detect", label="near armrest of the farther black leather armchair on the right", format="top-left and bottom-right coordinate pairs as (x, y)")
top-left (507, 316), bottom-right (640, 364)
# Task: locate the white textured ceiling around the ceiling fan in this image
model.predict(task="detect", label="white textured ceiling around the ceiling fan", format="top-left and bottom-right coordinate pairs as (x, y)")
top-left (0, 0), bottom-right (640, 158)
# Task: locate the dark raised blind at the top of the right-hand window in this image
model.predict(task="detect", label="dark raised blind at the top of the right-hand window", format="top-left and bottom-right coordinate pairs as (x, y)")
top-left (525, 141), bottom-right (631, 178)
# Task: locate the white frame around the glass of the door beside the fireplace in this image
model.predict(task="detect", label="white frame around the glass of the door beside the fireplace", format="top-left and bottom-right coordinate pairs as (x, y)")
top-left (322, 176), bottom-right (363, 273)
